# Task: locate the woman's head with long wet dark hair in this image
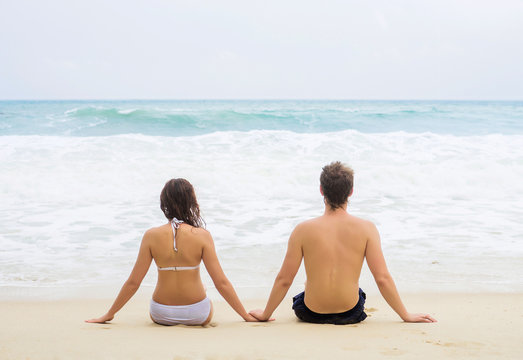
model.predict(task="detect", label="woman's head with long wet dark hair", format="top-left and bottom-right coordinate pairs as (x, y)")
top-left (160, 178), bottom-right (203, 227)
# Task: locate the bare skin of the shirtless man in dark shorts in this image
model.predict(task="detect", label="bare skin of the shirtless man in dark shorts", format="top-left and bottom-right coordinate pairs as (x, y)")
top-left (250, 189), bottom-right (436, 322)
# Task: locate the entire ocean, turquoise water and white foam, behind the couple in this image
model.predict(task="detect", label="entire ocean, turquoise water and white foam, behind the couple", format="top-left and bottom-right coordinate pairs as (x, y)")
top-left (0, 100), bottom-right (523, 298)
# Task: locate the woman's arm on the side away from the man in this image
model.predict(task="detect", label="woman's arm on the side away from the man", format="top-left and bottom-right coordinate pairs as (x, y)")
top-left (85, 231), bottom-right (153, 324)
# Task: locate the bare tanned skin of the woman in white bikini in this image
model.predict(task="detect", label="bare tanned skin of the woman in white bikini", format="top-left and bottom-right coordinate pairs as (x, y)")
top-left (86, 223), bottom-right (257, 325)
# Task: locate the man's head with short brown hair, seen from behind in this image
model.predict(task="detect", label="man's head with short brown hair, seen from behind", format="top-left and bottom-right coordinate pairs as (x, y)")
top-left (320, 161), bottom-right (354, 210)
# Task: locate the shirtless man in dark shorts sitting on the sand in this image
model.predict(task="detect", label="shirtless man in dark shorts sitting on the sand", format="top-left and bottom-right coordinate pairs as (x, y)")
top-left (250, 162), bottom-right (436, 325)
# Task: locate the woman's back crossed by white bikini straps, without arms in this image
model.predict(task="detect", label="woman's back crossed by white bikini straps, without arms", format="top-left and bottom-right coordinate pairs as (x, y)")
top-left (149, 224), bottom-right (207, 305)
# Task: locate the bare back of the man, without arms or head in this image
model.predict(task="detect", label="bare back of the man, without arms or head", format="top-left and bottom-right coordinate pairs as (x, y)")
top-left (295, 209), bottom-right (372, 313)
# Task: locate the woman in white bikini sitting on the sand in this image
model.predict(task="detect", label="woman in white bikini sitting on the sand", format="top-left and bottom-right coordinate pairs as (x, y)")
top-left (86, 179), bottom-right (256, 325)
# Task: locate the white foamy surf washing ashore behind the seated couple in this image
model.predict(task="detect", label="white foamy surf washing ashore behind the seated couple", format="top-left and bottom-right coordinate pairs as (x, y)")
top-left (0, 130), bottom-right (523, 295)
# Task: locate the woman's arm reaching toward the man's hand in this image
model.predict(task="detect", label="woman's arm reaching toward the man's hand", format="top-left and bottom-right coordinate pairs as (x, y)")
top-left (202, 231), bottom-right (257, 321)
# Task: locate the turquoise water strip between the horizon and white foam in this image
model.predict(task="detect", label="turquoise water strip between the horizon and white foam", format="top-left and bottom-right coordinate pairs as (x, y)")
top-left (0, 100), bottom-right (523, 136)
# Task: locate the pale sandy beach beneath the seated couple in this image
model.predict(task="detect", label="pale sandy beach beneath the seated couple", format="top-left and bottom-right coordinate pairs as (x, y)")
top-left (0, 290), bottom-right (523, 359)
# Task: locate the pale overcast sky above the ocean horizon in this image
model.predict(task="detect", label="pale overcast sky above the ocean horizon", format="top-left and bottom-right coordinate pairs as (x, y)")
top-left (0, 0), bottom-right (523, 100)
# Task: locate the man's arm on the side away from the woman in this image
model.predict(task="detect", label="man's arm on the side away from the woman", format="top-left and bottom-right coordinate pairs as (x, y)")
top-left (365, 224), bottom-right (436, 322)
